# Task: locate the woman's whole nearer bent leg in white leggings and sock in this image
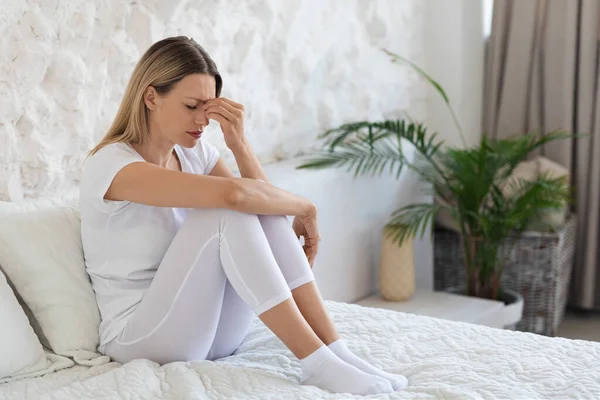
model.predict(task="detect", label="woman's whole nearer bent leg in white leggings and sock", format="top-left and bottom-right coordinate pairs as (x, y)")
top-left (106, 209), bottom-right (391, 394)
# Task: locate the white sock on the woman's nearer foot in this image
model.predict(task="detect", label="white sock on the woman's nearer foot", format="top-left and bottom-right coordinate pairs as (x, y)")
top-left (300, 345), bottom-right (394, 395)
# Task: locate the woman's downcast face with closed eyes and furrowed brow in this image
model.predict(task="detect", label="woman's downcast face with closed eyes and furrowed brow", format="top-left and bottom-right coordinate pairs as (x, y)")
top-left (144, 74), bottom-right (216, 148)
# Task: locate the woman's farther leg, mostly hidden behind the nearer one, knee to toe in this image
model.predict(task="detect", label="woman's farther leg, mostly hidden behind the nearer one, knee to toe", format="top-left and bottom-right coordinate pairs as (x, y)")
top-left (259, 215), bottom-right (408, 390)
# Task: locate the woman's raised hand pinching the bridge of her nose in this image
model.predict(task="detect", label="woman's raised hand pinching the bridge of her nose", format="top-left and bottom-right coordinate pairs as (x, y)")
top-left (202, 97), bottom-right (245, 149)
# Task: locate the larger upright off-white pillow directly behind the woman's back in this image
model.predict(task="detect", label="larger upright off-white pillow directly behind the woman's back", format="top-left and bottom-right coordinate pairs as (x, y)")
top-left (0, 201), bottom-right (109, 365)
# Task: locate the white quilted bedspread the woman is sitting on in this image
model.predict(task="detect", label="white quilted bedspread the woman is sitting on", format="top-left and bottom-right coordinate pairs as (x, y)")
top-left (0, 302), bottom-right (600, 400)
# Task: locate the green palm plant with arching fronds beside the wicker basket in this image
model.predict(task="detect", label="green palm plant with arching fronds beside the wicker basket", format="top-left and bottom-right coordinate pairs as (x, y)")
top-left (298, 50), bottom-right (573, 325)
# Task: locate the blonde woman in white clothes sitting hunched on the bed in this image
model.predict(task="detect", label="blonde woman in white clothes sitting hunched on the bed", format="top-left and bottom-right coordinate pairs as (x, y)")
top-left (80, 37), bottom-right (406, 394)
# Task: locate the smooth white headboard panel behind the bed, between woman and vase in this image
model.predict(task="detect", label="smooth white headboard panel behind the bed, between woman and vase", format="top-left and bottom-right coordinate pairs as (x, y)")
top-left (264, 146), bottom-right (433, 302)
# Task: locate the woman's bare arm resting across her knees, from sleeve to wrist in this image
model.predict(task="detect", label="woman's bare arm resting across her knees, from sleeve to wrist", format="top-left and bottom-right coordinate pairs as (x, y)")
top-left (104, 162), bottom-right (316, 216)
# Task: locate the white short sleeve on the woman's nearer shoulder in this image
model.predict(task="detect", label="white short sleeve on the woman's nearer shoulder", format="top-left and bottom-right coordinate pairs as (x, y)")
top-left (80, 143), bottom-right (145, 213)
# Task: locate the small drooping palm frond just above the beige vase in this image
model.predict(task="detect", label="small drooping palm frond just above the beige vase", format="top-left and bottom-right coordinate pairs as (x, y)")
top-left (385, 203), bottom-right (442, 244)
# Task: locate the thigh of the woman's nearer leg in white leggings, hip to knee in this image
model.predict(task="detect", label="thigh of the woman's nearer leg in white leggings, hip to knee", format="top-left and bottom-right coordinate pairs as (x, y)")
top-left (105, 212), bottom-right (241, 364)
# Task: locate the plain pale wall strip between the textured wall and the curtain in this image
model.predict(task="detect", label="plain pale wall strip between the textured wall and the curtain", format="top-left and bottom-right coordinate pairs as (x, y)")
top-left (423, 0), bottom-right (484, 146)
